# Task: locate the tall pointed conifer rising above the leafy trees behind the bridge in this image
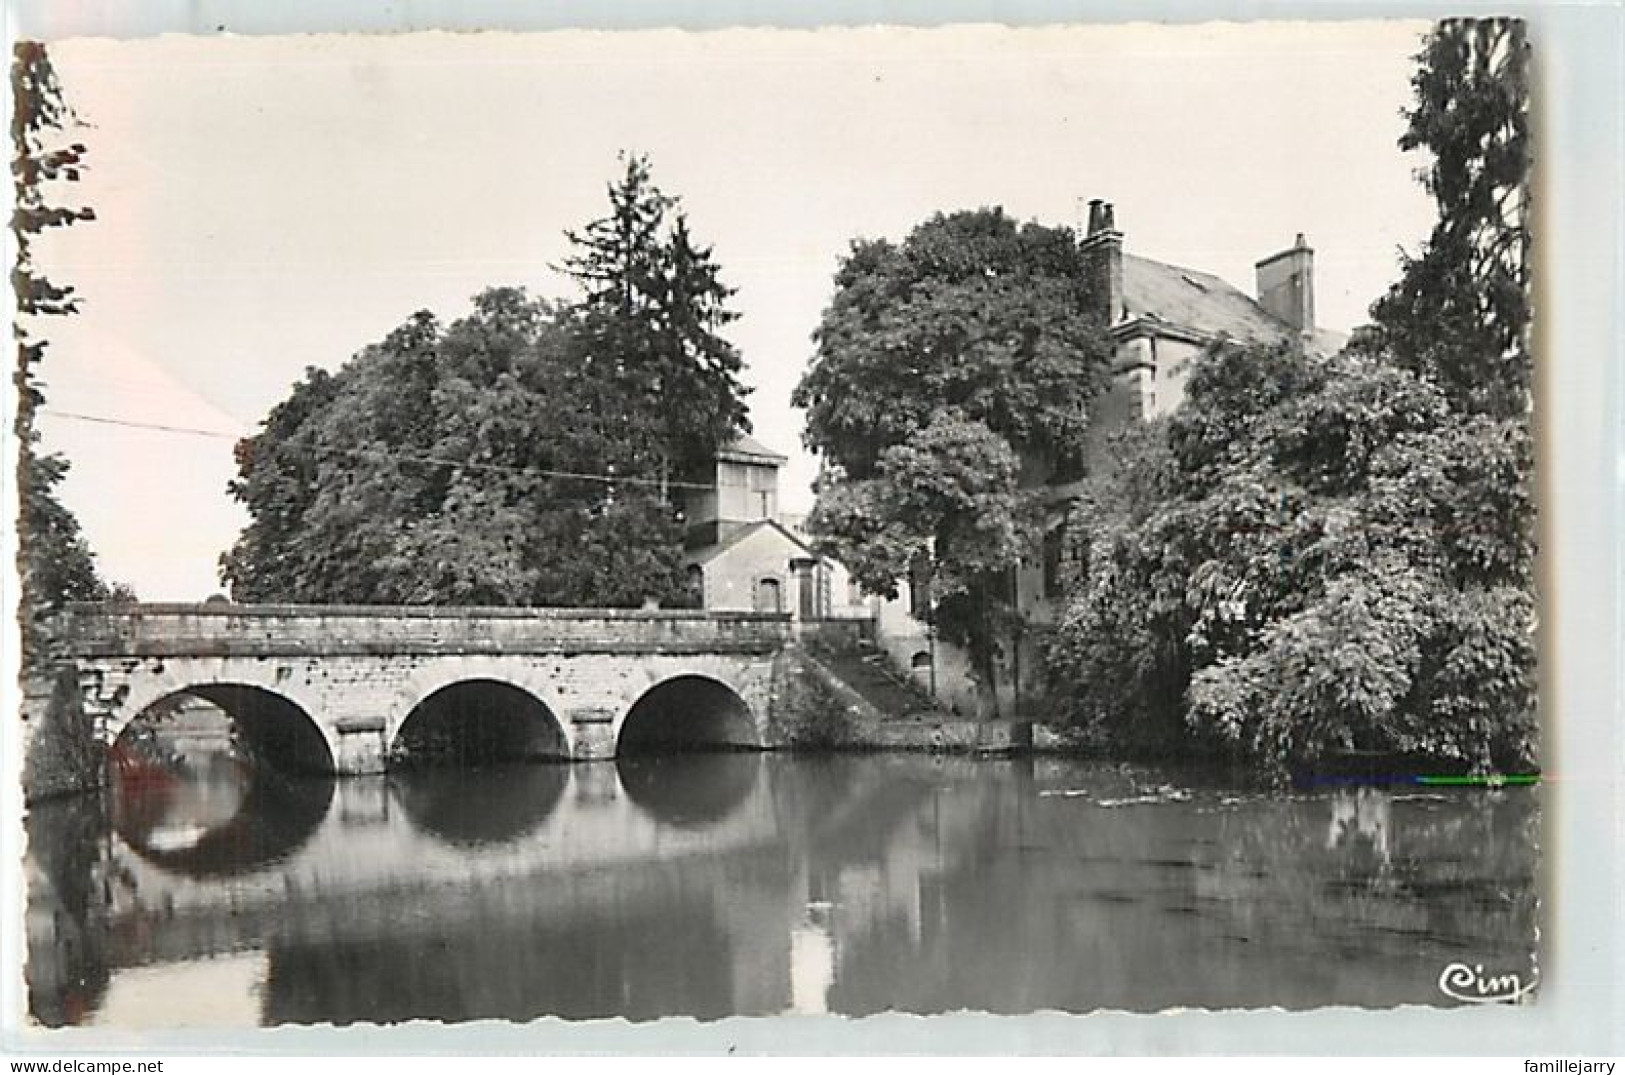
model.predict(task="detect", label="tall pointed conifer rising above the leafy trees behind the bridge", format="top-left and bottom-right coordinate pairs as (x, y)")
top-left (564, 154), bottom-right (749, 477)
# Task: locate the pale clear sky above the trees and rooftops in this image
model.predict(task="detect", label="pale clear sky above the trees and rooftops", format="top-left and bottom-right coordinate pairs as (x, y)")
top-left (22, 23), bottom-right (1432, 601)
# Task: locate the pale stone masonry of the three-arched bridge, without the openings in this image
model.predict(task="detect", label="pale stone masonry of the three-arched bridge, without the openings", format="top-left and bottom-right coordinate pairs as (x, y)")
top-left (63, 604), bottom-right (791, 773)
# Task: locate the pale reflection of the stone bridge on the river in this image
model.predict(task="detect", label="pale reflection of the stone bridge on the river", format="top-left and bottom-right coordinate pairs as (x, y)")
top-left (114, 753), bottom-right (777, 914)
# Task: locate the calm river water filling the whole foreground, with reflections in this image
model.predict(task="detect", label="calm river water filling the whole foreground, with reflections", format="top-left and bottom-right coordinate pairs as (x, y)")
top-left (26, 753), bottom-right (1539, 1028)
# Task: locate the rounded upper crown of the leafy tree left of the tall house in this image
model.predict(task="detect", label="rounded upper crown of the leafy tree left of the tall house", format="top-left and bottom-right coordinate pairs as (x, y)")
top-left (793, 209), bottom-right (1107, 479)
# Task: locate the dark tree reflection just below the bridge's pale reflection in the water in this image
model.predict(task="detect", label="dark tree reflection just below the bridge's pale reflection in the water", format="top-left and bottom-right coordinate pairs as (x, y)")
top-left (263, 861), bottom-right (788, 1025)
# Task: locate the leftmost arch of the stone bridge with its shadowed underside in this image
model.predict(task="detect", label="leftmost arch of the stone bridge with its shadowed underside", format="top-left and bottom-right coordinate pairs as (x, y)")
top-left (104, 675), bottom-right (338, 773)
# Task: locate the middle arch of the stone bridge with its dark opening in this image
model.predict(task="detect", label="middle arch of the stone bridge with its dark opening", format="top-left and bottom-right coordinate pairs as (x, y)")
top-left (385, 656), bottom-right (572, 763)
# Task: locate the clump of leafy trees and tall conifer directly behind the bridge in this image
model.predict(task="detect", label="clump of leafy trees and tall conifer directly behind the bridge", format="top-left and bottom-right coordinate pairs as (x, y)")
top-left (221, 159), bottom-right (743, 606)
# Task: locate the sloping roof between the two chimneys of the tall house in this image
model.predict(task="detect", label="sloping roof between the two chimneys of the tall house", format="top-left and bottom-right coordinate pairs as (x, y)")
top-left (1123, 252), bottom-right (1294, 343)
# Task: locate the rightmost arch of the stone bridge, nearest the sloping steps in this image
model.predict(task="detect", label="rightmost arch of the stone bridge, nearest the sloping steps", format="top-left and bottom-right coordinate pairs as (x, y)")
top-left (616, 672), bottom-right (762, 755)
